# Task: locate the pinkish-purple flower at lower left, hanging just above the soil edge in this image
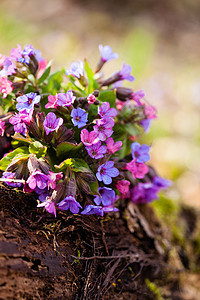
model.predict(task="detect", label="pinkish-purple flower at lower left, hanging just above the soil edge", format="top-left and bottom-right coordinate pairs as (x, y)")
top-left (27, 170), bottom-right (49, 190)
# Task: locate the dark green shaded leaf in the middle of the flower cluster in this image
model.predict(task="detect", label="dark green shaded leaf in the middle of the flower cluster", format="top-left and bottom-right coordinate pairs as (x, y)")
top-left (56, 142), bottom-right (83, 159)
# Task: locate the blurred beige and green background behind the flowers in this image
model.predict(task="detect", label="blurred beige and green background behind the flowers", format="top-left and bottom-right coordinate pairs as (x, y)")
top-left (0, 0), bottom-right (200, 208)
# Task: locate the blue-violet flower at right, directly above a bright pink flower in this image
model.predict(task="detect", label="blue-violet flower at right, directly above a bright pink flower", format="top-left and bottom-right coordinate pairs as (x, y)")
top-left (131, 142), bottom-right (150, 163)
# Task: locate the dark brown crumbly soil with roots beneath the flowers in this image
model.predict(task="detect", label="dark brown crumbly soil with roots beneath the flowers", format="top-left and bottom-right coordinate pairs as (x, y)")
top-left (0, 185), bottom-right (198, 300)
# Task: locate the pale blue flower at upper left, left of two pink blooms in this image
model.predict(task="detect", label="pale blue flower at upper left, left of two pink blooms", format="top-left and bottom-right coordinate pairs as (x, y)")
top-left (16, 93), bottom-right (41, 112)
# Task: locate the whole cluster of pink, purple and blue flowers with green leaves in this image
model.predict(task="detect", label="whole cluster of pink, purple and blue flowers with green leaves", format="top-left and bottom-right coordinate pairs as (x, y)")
top-left (0, 45), bottom-right (170, 217)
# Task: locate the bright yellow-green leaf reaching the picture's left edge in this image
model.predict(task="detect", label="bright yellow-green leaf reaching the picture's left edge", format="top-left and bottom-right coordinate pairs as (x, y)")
top-left (0, 147), bottom-right (29, 171)
